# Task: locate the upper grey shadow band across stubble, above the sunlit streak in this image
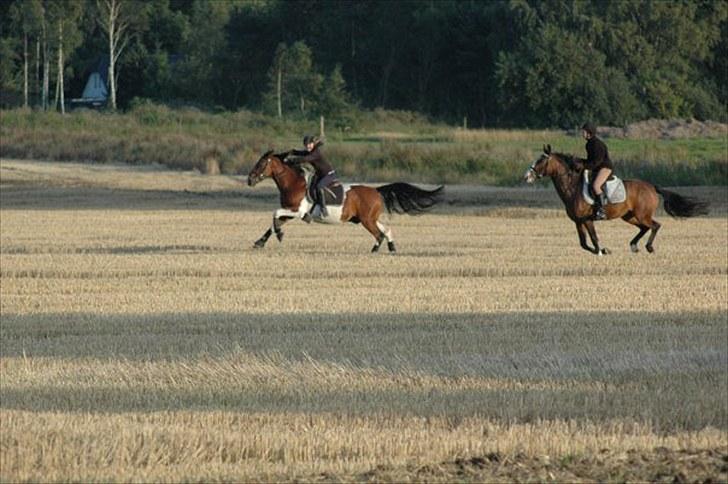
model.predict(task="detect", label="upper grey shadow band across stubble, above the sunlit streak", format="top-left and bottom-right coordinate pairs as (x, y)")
top-left (0, 311), bottom-right (728, 366)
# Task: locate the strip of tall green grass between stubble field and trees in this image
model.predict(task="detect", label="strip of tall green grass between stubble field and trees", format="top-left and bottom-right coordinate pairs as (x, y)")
top-left (0, 103), bottom-right (728, 186)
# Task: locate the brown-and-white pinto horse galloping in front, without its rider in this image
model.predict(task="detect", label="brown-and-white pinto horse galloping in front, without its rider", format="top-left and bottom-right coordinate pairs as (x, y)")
top-left (248, 151), bottom-right (443, 252)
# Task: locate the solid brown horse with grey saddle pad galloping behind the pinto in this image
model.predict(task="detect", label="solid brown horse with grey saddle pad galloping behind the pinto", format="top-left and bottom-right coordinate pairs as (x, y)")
top-left (524, 145), bottom-right (708, 255)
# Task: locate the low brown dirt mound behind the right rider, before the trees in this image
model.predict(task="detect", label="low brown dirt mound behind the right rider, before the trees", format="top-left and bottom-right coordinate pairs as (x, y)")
top-left (597, 119), bottom-right (728, 139)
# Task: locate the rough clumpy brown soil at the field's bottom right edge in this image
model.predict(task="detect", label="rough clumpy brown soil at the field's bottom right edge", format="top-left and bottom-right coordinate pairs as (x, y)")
top-left (357, 447), bottom-right (728, 482)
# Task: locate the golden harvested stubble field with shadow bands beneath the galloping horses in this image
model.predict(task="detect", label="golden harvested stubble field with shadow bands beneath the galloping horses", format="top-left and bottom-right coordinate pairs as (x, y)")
top-left (0, 160), bottom-right (728, 482)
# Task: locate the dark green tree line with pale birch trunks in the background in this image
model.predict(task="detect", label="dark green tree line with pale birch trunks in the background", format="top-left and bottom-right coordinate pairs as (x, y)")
top-left (0, 0), bottom-right (728, 127)
